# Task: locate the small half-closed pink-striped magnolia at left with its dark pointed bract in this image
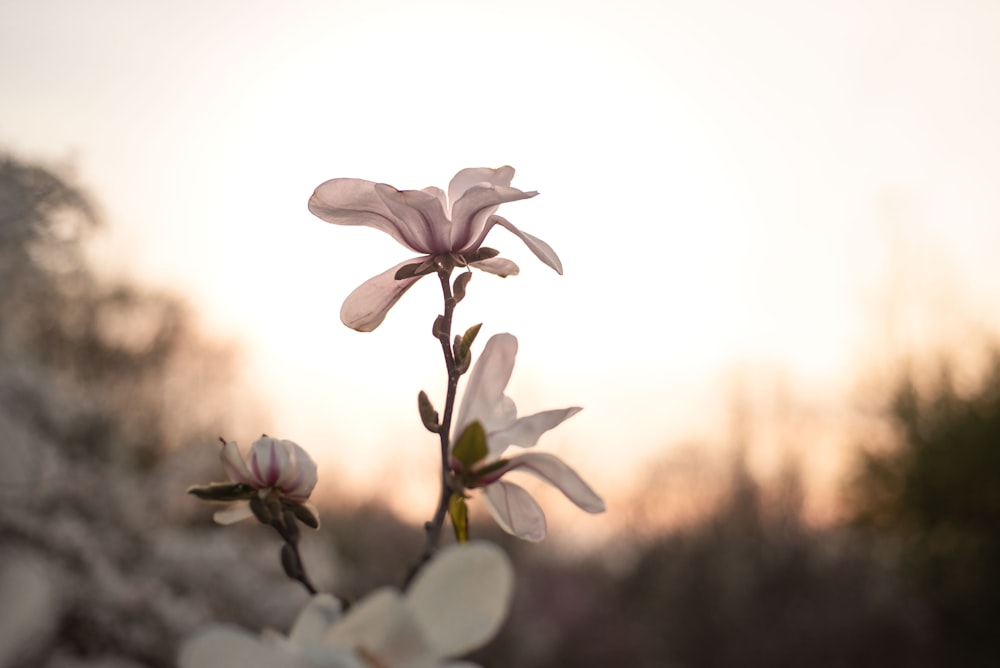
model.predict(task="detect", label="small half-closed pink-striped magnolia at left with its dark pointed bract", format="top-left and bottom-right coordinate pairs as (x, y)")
top-left (188, 435), bottom-right (319, 528)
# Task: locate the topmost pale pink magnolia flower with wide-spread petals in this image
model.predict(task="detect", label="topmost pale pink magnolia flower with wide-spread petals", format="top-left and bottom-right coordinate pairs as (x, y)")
top-left (309, 167), bottom-right (562, 332)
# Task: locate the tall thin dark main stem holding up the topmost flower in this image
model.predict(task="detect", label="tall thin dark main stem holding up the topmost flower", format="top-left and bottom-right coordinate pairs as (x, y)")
top-left (404, 263), bottom-right (461, 588)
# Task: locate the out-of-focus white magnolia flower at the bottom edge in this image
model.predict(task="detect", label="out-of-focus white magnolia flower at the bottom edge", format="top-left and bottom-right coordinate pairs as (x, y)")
top-left (178, 543), bottom-right (514, 668)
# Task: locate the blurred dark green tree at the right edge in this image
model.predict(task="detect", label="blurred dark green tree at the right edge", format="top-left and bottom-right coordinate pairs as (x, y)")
top-left (850, 354), bottom-right (1000, 666)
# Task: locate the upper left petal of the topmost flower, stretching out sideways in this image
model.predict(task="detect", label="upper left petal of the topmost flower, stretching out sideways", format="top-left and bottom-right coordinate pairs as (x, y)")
top-left (309, 179), bottom-right (423, 253)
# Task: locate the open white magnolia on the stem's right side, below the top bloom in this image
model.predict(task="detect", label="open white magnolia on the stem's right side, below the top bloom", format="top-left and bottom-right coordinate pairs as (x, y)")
top-left (451, 334), bottom-right (604, 541)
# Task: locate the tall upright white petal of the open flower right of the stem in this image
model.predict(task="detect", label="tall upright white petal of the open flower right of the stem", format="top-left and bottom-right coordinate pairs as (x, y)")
top-left (455, 334), bottom-right (517, 434)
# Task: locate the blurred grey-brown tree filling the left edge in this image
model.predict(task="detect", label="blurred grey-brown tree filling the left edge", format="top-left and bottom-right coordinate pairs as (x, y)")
top-left (0, 155), bottom-right (278, 666)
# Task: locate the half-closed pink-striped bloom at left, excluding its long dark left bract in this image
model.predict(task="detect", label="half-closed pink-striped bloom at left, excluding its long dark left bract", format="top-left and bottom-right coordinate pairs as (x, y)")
top-left (214, 436), bottom-right (319, 526)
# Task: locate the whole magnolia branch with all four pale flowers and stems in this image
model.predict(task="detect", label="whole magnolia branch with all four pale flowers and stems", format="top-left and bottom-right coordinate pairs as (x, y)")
top-left (180, 167), bottom-right (604, 668)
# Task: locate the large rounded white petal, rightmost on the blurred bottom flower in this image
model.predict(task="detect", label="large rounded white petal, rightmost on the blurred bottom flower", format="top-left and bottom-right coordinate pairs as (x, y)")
top-left (406, 542), bottom-right (514, 658)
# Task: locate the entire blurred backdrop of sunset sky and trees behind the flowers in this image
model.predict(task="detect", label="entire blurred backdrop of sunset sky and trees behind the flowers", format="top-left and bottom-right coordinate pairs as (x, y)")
top-left (0, 0), bottom-right (1000, 667)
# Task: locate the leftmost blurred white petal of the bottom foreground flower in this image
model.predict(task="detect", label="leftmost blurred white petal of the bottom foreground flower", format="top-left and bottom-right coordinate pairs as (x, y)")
top-left (177, 626), bottom-right (294, 668)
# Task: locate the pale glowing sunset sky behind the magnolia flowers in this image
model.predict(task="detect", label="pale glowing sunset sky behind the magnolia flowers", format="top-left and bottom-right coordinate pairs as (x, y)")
top-left (0, 0), bottom-right (1000, 532)
